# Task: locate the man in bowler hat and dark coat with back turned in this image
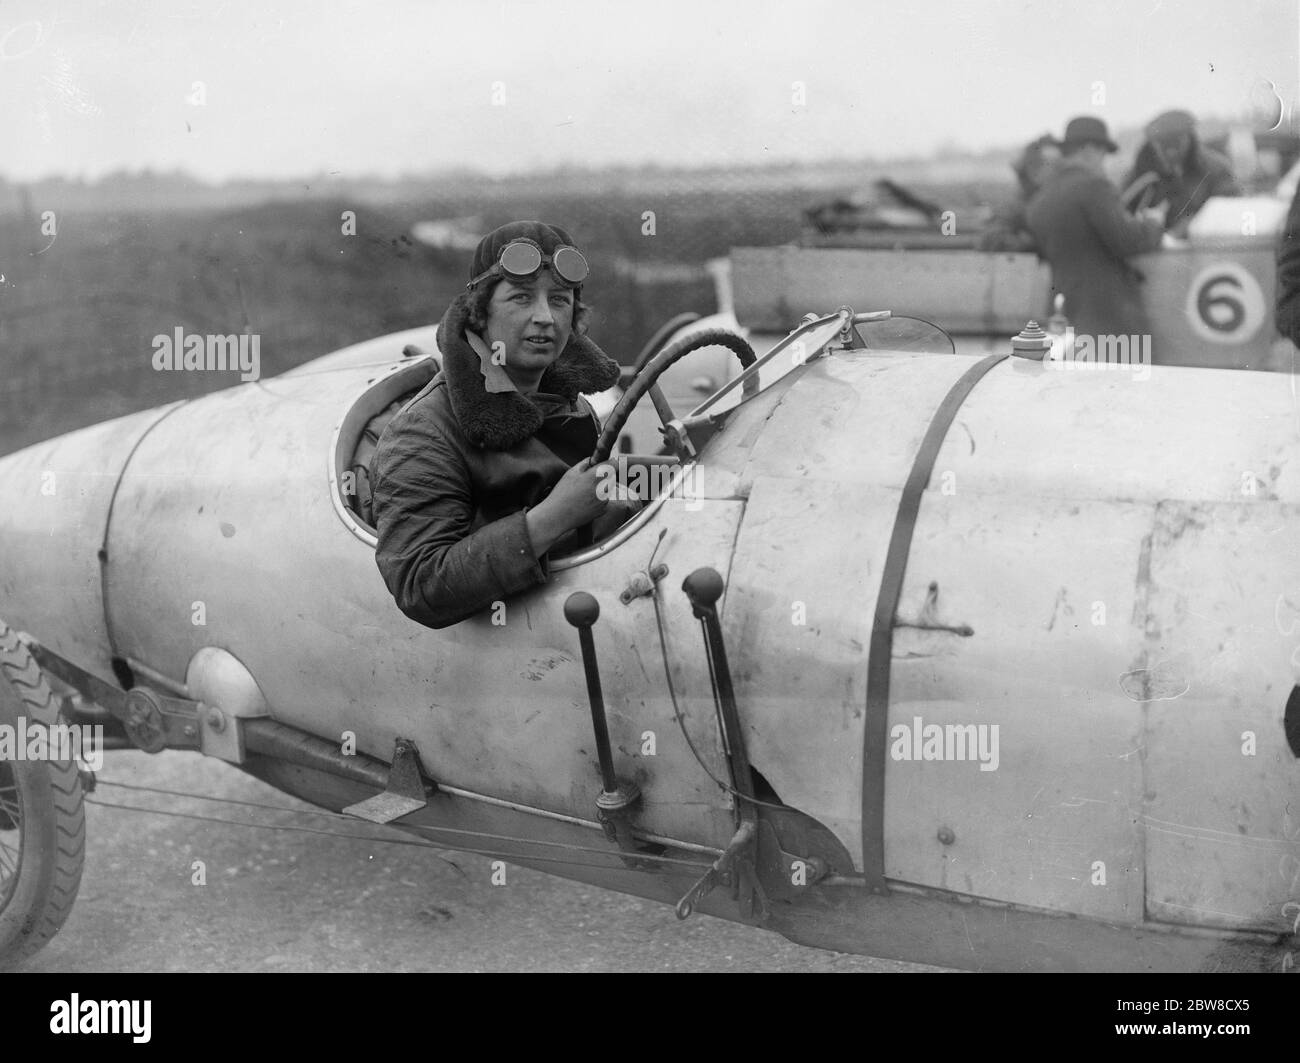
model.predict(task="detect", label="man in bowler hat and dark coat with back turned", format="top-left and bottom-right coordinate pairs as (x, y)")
top-left (1026, 117), bottom-right (1164, 337)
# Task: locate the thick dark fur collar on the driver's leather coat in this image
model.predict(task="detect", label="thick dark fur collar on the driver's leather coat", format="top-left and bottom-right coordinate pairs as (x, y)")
top-left (438, 292), bottom-right (619, 451)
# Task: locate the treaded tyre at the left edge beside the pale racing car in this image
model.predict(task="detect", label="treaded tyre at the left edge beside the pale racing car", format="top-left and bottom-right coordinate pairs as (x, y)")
top-left (0, 621), bottom-right (86, 968)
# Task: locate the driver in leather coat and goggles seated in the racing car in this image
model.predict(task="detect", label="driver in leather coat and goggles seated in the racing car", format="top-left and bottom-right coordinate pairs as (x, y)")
top-left (372, 221), bottom-right (637, 628)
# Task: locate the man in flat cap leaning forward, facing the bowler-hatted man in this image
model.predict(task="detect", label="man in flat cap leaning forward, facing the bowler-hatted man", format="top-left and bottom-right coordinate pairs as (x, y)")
top-left (1122, 110), bottom-right (1242, 235)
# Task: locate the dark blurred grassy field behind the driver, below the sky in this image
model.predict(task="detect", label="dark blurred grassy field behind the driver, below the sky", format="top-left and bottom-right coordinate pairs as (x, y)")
top-left (0, 178), bottom-right (998, 454)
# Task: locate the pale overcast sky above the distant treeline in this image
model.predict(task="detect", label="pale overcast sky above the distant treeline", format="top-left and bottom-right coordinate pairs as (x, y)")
top-left (0, 0), bottom-right (1300, 181)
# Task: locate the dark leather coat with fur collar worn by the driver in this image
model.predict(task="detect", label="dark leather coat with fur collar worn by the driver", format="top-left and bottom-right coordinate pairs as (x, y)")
top-left (372, 295), bottom-right (619, 628)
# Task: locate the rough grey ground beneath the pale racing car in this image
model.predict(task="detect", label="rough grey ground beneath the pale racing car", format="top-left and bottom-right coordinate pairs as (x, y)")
top-left (15, 752), bottom-right (932, 972)
